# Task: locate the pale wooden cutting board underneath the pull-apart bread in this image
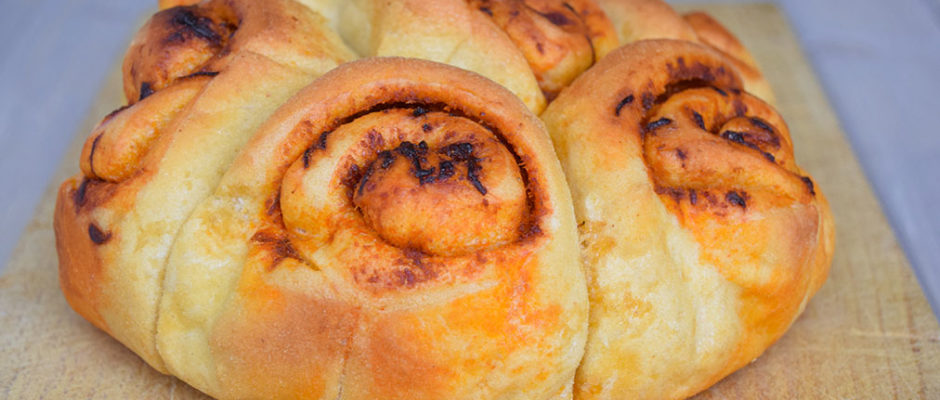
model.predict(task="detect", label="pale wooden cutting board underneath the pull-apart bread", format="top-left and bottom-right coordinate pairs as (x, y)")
top-left (0, 4), bottom-right (940, 399)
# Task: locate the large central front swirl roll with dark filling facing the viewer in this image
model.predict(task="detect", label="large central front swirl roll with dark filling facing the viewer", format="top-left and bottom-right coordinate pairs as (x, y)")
top-left (157, 58), bottom-right (588, 399)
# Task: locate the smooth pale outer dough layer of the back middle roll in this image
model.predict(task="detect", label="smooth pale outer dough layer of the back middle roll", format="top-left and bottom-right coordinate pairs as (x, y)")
top-left (302, 0), bottom-right (545, 112)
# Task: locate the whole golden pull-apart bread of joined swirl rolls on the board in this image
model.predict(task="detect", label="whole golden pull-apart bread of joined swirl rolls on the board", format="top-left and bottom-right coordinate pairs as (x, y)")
top-left (54, 0), bottom-right (833, 399)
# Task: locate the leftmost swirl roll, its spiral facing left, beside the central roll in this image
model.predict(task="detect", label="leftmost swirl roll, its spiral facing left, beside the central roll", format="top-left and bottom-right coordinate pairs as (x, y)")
top-left (54, 0), bottom-right (353, 372)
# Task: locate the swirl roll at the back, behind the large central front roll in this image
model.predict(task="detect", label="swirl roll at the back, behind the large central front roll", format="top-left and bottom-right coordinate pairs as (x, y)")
top-left (294, 0), bottom-right (617, 113)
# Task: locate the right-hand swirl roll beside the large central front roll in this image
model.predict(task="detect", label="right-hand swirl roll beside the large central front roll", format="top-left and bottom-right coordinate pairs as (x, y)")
top-left (542, 40), bottom-right (833, 399)
